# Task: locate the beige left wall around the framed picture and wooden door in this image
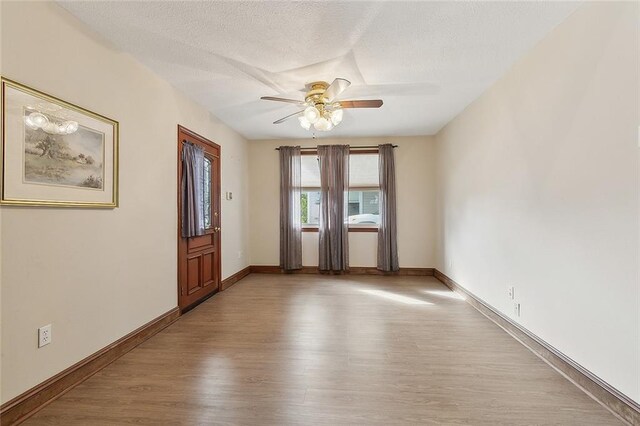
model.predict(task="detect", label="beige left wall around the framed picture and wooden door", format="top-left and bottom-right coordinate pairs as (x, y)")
top-left (0, 2), bottom-right (248, 402)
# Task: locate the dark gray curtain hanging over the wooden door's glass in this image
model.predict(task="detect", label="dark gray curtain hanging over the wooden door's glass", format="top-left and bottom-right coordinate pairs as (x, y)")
top-left (182, 142), bottom-right (204, 238)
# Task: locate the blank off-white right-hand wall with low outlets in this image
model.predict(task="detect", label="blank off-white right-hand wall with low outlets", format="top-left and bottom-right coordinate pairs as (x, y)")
top-left (437, 3), bottom-right (640, 402)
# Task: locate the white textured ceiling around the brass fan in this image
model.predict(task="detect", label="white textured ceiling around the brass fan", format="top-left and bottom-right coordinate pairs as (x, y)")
top-left (60, 1), bottom-right (579, 139)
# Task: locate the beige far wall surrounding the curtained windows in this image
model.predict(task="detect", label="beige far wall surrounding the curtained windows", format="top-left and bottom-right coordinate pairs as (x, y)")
top-left (249, 136), bottom-right (436, 268)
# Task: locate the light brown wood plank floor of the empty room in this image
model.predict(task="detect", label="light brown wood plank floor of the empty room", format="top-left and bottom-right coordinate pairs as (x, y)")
top-left (25, 274), bottom-right (622, 425)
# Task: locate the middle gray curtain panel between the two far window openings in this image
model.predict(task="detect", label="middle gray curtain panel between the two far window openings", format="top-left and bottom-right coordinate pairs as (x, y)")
top-left (318, 145), bottom-right (349, 271)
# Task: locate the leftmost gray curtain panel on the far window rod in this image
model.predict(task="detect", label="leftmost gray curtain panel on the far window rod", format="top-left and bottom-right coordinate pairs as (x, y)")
top-left (279, 146), bottom-right (302, 271)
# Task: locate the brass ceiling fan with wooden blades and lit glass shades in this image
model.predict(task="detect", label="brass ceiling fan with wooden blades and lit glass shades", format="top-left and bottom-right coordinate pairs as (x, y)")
top-left (260, 78), bottom-right (382, 132)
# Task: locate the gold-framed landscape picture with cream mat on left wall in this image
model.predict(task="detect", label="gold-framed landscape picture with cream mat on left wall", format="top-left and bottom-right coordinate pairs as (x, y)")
top-left (0, 78), bottom-right (118, 208)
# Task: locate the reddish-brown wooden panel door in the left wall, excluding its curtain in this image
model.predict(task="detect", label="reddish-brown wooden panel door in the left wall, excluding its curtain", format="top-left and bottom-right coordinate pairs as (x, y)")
top-left (178, 126), bottom-right (220, 311)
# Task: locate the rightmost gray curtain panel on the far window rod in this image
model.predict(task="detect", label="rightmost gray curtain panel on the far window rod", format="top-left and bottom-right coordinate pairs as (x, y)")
top-left (378, 144), bottom-right (400, 271)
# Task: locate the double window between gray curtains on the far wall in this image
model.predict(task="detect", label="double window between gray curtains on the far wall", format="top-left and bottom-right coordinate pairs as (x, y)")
top-left (300, 152), bottom-right (380, 228)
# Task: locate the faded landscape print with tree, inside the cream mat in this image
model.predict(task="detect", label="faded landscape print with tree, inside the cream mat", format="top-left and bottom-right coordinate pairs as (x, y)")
top-left (24, 111), bottom-right (105, 190)
